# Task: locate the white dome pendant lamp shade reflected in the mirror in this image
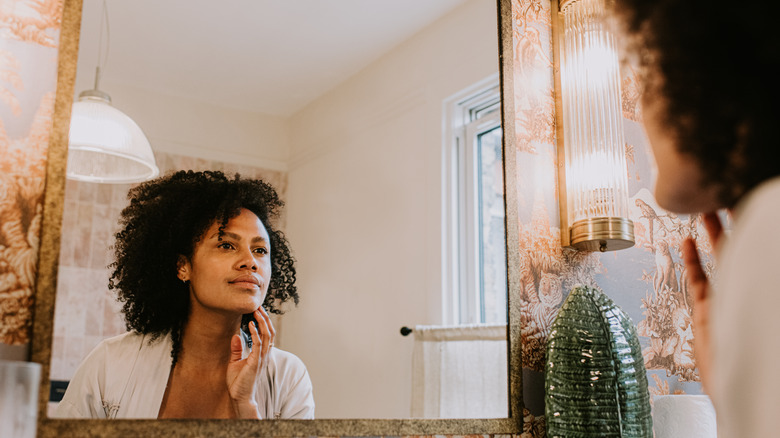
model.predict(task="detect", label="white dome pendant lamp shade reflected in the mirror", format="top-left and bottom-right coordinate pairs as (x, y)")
top-left (67, 99), bottom-right (160, 184)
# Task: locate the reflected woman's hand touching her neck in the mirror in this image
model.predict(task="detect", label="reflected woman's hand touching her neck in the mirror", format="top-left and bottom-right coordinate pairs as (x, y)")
top-left (227, 306), bottom-right (276, 419)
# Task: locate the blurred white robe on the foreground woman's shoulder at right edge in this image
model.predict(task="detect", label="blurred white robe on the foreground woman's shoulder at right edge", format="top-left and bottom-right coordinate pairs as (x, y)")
top-left (708, 176), bottom-right (780, 438)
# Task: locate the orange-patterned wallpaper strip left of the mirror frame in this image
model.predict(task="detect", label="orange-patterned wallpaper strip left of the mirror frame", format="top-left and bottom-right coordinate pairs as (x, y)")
top-left (0, 0), bottom-right (62, 346)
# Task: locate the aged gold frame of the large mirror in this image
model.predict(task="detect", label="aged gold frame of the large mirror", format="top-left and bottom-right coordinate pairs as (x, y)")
top-left (32, 0), bottom-right (523, 437)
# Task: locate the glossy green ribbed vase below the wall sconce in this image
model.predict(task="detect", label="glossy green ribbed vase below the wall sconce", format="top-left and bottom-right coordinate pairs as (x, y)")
top-left (544, 286), bottom-right (653, 438)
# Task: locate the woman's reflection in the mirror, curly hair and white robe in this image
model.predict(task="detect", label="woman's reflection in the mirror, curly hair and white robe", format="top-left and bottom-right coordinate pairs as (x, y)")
top-left (57, 171), bottom-right (314, 419)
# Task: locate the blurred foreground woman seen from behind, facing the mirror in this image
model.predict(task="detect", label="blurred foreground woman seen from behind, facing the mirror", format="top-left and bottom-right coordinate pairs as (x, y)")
top-left (615, 0), bottom-right (780, 437)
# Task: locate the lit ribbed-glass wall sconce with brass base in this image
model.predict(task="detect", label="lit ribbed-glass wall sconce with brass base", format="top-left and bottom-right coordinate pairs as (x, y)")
top-left (552, 0), bottom-right (634, 252)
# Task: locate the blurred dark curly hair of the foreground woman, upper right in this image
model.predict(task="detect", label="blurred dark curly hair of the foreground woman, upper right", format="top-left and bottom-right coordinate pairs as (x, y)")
top-left (611, 0), bottom-right (780, 207)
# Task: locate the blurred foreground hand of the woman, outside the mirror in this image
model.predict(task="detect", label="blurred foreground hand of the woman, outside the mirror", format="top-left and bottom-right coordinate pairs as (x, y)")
top-left (682, 212), bottom-right (723, 392)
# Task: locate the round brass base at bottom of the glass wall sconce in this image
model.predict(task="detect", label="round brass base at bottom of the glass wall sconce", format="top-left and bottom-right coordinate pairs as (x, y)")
top-left (571, 217), bottom-right (634, 252)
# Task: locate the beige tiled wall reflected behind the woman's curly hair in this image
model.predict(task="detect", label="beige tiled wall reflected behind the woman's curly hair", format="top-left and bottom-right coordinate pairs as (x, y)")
top-left (50, 153), bottom-right (287, 380)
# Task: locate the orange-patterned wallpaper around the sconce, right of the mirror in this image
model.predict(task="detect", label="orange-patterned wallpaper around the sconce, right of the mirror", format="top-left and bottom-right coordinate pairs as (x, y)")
top-left (512, 0), bottom-right (713, 436)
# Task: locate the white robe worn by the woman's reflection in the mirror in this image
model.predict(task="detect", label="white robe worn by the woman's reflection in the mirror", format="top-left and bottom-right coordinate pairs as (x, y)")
top-left (55, 332), bottom-right (314, 419)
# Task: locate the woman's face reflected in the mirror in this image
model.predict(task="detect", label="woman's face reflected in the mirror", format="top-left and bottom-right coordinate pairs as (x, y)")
top-left (178, 209), bottom-right (271, 315)
